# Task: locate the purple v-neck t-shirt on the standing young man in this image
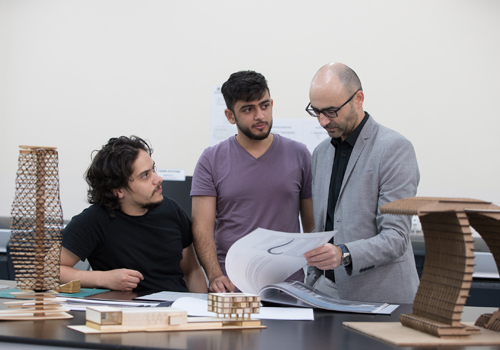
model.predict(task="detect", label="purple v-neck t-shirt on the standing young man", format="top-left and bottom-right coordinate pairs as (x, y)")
top-left (191, 135), bottom-right (312, 279)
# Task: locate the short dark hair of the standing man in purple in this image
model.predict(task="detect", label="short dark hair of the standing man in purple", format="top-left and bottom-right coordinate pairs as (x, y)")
top-left (221, 70), bottom-right (269, 112)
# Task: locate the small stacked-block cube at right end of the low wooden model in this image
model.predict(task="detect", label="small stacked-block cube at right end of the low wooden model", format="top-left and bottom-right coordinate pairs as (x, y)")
top-left (208, 293), bottom-right (260, 318)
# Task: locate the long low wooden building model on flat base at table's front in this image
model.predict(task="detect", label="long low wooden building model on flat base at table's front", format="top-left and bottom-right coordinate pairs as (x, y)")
top-left (68, 293), bottom-right (266, 334)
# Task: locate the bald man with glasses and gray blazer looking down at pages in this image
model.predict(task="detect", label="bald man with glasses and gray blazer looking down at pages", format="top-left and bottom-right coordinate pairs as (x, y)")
top-left (305, 63), bottom-right (420, 303)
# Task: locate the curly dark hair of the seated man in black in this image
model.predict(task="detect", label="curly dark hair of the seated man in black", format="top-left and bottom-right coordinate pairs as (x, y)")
top-left (85, 136), bottom-right (153, 217)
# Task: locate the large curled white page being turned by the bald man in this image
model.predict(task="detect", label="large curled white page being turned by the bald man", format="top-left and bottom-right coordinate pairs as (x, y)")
top-left (226, 228), bottom-right (336, 294)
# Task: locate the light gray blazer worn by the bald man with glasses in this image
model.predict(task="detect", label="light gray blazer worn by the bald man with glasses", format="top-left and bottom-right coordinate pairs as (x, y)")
top-left (312, 116), bottom-right (420, 303)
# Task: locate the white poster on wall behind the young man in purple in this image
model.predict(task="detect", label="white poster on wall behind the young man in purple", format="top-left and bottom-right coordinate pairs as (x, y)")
top-left (210, 85), bottom-right (328, 153)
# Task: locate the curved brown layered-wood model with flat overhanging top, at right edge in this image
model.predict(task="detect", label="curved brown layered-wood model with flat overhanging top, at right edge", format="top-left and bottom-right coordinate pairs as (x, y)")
top-left (380, 197), bottom-right (500, 338)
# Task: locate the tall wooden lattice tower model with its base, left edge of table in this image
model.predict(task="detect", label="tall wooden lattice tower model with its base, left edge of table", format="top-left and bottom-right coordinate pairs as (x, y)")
top-left (0, 146), bottom-right (73, 320)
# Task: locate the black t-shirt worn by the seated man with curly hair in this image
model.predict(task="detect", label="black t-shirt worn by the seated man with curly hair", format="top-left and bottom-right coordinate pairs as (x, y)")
top-left (62, 197), bottom-right (193, 292)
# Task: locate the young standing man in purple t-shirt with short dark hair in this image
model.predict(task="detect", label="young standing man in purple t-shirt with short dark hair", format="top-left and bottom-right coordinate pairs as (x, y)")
top-left (191, 71), bottom-right (314, 292)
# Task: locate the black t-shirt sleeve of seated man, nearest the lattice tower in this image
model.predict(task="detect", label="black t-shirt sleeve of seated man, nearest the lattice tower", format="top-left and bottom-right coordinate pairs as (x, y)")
top-left (62, 208), bottom-right (99, 261)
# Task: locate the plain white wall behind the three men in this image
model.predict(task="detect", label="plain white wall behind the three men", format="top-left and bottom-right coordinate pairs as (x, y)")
top-left (0, 0), bottom-right (500, 219)
